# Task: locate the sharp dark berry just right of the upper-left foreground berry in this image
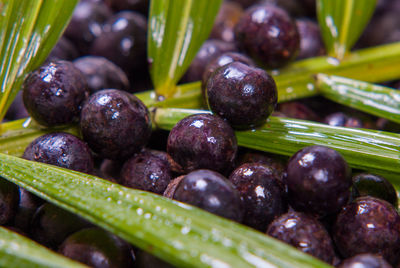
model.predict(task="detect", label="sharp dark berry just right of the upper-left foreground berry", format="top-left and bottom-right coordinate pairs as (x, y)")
top-left (80, 89), bottom-right (151, 160)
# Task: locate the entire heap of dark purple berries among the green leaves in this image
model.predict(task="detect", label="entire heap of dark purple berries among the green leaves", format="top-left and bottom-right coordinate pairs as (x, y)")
top-left (0, 0), bottom-right (400, 267)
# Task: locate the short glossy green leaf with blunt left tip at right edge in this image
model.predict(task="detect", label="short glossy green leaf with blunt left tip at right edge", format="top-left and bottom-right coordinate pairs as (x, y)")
top-left (316, 74), bottom-right (400, 123)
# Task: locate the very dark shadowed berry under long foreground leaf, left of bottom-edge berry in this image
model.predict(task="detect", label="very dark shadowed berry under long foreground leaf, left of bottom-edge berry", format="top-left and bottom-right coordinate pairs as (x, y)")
top-left (30, 203), bottom-right (91, 249)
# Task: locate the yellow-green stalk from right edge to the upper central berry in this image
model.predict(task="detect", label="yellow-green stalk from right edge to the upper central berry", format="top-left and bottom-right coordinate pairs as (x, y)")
top-left (274, 42), bottom-right (400, 102)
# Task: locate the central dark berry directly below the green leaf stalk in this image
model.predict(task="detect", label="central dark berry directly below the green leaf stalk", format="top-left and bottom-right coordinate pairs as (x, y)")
top-left (167, 114), bottom-right (237, 173)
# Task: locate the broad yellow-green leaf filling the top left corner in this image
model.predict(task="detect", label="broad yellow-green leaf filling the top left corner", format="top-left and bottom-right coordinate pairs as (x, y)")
top-left (0, 0), bottom-right (78, 120)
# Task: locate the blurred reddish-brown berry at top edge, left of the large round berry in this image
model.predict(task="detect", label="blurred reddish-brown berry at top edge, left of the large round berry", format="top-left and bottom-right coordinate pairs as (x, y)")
top-left (210, 1), bottom-right (243, 42)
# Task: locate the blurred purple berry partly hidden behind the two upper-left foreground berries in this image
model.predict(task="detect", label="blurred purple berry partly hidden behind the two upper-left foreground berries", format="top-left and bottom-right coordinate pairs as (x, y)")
top-left (74, 56), bottom-right (130, 94)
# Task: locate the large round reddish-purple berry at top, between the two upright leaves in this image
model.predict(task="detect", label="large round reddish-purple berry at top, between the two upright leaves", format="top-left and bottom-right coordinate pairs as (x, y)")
top-left (235, 4), bottom-right (300, 69)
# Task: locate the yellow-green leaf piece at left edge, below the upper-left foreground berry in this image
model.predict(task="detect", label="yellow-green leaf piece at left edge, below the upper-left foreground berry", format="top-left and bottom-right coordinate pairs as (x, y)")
top-left (0, 118), bottom-right (79, 156)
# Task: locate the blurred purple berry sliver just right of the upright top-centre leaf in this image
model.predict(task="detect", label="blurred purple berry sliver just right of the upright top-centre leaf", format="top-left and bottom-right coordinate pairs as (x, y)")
top-left (183, 40), bottom-right (236, 82)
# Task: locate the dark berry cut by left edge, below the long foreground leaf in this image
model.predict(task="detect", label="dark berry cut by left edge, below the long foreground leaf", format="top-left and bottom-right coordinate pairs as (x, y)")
top-left (0, 177), bottom-right (19, 225)
